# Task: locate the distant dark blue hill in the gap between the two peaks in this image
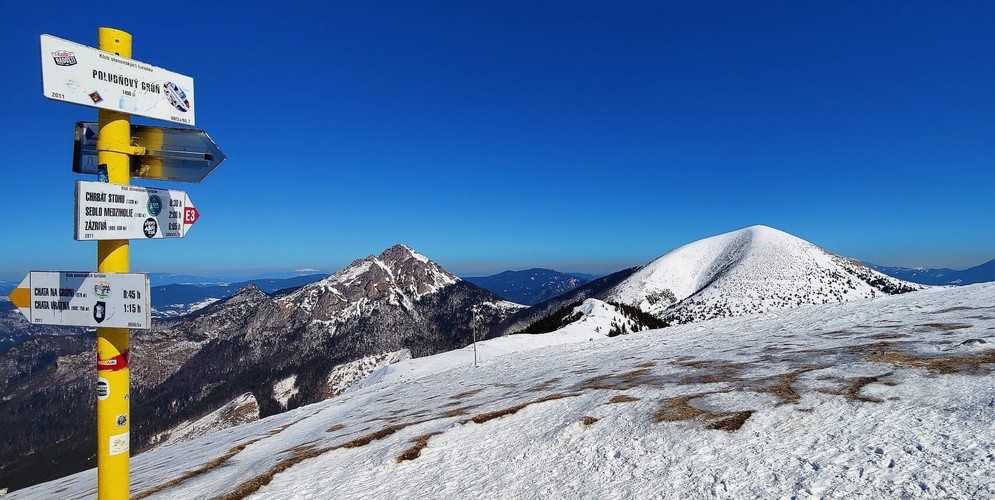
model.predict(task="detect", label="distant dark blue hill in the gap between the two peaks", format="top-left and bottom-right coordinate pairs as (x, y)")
top-left (463, 268), bottom-right (591, 305)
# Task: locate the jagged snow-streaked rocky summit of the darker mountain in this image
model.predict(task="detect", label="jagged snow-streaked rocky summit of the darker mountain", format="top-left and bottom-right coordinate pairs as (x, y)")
top-left (281, 244), bottom-right (459, 320)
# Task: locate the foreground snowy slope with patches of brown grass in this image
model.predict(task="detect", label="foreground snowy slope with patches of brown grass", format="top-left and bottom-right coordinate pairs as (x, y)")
top-left (17, 284), bottom-right (995, 499)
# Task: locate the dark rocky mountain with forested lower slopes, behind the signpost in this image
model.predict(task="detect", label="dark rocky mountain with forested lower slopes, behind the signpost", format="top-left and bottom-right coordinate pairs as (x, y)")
top-left (0, 245), bottom-right (523, 485)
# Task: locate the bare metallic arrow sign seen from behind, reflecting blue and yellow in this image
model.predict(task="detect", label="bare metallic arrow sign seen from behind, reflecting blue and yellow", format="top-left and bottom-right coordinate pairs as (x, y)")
top-left (73, 122), bottom-right (227, 182)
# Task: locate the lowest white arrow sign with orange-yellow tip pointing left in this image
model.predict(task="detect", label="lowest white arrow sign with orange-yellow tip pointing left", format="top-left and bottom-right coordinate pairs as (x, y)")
top-left (10, 271), bottom-right (151, 330)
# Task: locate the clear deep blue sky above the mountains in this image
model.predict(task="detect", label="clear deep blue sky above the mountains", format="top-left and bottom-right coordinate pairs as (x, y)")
top-left (0, 0), bottom-right (995, 279)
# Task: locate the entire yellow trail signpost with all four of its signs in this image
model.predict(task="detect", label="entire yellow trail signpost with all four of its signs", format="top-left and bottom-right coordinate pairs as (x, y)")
top-left (35, 28), bottom-right (225, 500)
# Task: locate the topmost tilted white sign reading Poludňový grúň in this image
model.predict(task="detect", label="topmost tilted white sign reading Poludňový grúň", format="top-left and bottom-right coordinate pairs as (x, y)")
top-left (41, 35), bottom-right (195, 125)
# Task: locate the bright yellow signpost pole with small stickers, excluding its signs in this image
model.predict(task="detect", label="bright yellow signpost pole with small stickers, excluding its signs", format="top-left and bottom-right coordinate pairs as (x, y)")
top-left (97, 28), bottom-right (131, 500)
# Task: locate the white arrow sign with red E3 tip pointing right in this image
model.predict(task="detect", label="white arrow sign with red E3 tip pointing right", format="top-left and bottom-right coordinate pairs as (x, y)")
top-left (75, 181), bottom-right (200, 241)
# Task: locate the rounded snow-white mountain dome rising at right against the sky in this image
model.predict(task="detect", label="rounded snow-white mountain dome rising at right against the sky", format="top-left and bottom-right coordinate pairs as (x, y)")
top-left (606, 226), bottom-right (922, 323)
